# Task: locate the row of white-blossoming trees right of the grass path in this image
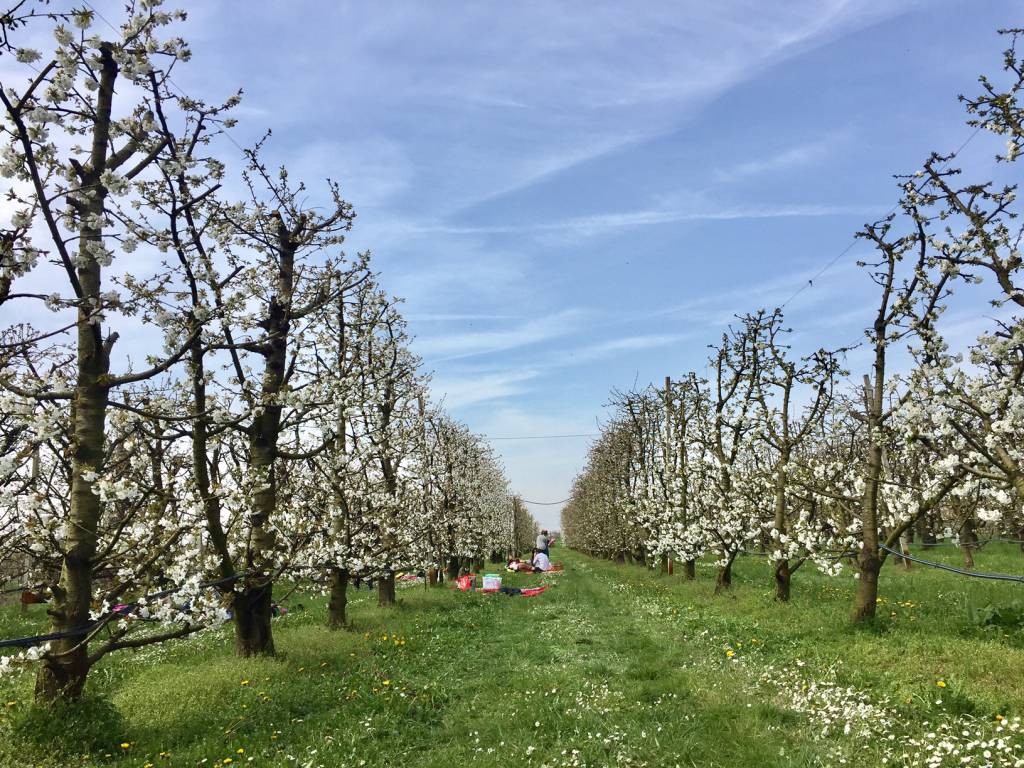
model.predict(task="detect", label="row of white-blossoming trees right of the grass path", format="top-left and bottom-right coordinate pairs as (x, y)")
top-left (562, 31), bottom-right (1024, 621)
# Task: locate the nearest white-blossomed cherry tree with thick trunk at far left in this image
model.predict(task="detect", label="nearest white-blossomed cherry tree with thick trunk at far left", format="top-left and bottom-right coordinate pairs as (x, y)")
top-left (0, 1), bottom-right (253, 699)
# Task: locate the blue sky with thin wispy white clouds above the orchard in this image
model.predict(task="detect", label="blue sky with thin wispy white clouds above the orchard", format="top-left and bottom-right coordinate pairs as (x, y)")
top-left (4, 0), bottom-right (1022, 527)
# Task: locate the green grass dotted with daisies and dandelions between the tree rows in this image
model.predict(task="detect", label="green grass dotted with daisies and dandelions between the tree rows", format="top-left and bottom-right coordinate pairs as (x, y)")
top-left (0, 545), bottom-right (1024, 768)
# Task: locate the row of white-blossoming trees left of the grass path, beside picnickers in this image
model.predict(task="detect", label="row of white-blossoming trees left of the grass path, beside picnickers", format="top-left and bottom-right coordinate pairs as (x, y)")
top-left (0, 0), bottom-right (536, 700)
